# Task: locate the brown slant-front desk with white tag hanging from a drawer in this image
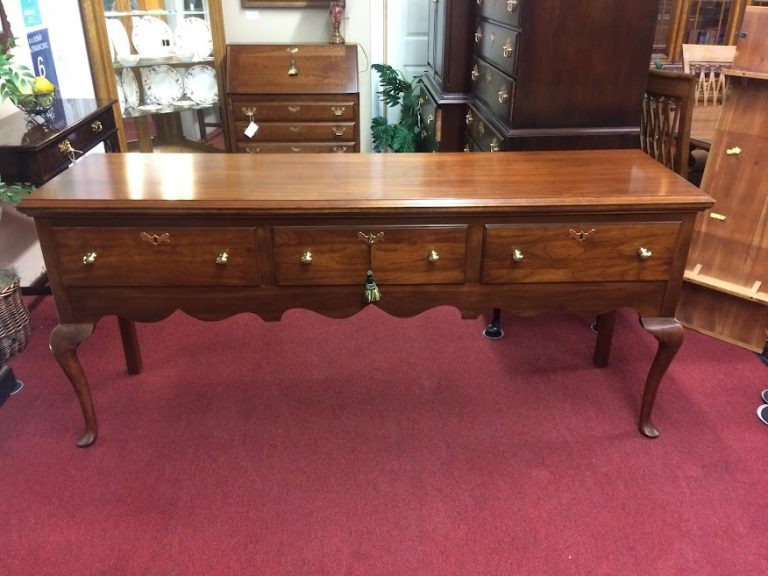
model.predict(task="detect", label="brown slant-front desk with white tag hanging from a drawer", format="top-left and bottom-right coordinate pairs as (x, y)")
top-left (226, 44), bottom-right (360, 153)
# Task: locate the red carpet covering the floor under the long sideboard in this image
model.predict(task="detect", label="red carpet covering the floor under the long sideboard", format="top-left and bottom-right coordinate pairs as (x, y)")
top-left (0, 298), bottom-right (768, 576)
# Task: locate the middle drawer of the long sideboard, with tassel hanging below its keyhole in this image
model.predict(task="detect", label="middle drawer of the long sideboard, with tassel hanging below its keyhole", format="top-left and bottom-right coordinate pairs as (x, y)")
top-left (273, 225), bottom-right (467, 286)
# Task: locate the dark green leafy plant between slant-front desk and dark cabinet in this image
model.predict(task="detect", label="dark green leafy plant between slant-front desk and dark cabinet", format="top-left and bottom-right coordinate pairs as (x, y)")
top-left (371, 64), bottom-right (421, 152)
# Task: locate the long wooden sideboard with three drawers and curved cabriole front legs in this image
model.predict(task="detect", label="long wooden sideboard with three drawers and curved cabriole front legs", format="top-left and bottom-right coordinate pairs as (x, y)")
top-left (19, 150), bottom-right (712, 446)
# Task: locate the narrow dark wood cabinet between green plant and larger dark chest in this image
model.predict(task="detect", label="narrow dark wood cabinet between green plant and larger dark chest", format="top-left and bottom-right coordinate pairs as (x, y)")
top-left (421, 0), bottom-right (475, 152)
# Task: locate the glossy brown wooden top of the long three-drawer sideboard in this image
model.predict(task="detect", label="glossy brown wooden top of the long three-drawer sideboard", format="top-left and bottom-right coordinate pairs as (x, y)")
top-left (19, 150), bottom-right (712, 216)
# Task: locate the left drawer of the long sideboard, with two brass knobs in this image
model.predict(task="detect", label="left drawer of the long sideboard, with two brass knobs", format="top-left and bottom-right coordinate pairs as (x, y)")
top-left (53, 226), bottom-right (259, 286)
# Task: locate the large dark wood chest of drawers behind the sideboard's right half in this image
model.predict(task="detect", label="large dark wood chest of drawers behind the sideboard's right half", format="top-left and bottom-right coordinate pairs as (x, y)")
top-left (465, 0), bottom-right (658, 151)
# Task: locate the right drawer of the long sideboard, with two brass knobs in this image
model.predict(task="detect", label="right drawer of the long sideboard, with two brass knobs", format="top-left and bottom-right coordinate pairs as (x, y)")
top-left (482, 222), bottom-right (679, 284)
